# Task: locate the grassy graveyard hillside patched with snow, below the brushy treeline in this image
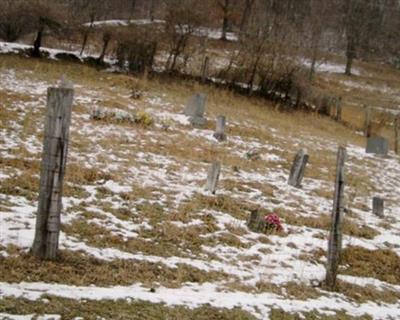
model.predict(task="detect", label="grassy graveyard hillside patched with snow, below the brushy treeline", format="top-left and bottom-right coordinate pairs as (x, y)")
top-left (0, 56), bottom-right (400, 319)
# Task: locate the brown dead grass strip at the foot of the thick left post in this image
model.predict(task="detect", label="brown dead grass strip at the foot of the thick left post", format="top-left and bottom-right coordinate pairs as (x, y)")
top-left (0, 251), bottom-right (227, 288)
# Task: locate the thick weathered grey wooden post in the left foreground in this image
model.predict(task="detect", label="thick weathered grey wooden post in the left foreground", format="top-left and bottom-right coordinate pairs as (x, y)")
top-left (32, 81), bottom-right (74, 260)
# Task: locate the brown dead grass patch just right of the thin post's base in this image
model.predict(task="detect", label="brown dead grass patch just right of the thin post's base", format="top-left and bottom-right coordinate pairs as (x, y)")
top-left (342, 246), bottom-right (400, 284)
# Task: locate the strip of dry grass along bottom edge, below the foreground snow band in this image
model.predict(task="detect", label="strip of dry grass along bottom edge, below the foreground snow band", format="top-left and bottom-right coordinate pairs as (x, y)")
top-left (0, 295), bottom-right (255, 320)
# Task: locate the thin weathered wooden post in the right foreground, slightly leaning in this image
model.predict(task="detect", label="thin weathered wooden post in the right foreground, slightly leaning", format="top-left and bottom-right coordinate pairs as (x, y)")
top-left (325, 146), bottom-right (346, 290)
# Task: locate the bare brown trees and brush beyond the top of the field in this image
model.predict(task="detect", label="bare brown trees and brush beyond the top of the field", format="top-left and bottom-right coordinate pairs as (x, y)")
top-left (0, 0), bottom-right (400, 109)
